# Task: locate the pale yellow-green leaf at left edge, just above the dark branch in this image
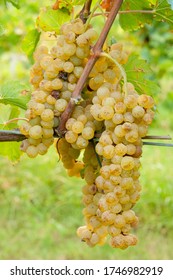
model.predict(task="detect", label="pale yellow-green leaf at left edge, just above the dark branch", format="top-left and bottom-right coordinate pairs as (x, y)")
top-left (0, 104), bottom-right (20, 130)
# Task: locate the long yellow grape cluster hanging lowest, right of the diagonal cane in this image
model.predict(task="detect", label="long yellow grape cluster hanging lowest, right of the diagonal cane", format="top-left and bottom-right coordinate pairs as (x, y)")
top-left (77, 83), bottom-right (154, 249)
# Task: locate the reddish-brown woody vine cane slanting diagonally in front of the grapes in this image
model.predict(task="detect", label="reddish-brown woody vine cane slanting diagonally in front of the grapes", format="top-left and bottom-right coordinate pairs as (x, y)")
top-left (57, 0), bottom-right (123, 136)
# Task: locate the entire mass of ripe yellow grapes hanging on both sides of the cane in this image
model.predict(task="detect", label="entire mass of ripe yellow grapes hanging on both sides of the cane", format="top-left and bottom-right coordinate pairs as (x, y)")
top-left (20, 19), bottom-right (154, 249)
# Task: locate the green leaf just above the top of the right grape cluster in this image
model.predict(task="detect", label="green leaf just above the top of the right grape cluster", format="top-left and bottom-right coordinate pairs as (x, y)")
top-left (124, 55), bottom-right (160, 95)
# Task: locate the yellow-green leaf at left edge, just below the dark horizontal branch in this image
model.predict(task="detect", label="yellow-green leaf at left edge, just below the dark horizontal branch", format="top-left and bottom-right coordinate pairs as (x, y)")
top-left (0, 142), bottom-right (22, 162)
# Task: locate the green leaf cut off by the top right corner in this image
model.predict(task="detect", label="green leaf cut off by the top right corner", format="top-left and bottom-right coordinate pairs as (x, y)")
top-left (154, 0), bottom-right (173, 27)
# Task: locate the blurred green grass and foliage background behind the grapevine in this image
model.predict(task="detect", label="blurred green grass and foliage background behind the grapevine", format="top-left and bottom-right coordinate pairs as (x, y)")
top-left (0, 0), bottom-right (173, 259)
